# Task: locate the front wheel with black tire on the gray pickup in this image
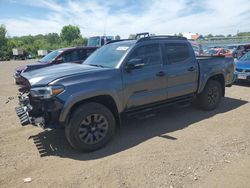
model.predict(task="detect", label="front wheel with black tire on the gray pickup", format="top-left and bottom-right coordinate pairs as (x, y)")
top-left (65, 103), bottom-right (116, 152)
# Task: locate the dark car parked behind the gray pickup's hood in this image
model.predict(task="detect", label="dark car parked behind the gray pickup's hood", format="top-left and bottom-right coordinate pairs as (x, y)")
top-left (14, 46), bottom-right (98, 84)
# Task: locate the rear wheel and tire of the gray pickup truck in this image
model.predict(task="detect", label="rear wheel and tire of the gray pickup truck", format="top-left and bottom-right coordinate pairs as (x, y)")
top-left (195, 80), bottom-right (222, 110)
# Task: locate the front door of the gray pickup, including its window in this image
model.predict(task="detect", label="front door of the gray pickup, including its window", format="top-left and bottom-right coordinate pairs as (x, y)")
top-left (123, 43), bottom-right (167, 109)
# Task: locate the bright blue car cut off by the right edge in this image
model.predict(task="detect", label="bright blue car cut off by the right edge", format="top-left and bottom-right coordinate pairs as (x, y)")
top-left (235, 52), bottom-right (250, 81)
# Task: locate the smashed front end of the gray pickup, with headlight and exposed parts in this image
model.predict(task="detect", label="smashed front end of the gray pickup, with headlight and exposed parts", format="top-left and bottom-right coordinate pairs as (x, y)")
top-left (16, 77), bottom-right (64, 129)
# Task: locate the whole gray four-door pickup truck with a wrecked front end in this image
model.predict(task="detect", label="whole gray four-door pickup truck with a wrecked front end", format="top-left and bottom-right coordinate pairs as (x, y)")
top-left (16, 36), bottom-right (234, 151)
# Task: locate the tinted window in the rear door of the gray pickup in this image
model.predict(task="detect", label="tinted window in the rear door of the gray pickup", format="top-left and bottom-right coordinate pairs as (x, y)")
top-left (165, 43), bottom-right (189, 63)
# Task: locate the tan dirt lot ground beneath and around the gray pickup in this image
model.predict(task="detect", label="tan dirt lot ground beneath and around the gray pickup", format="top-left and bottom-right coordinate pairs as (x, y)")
top-left (0, 61), bottom-right (250, 188)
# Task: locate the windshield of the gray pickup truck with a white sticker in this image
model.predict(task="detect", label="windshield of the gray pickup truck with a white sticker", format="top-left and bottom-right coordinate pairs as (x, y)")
top-left (84, 42), bottom-right (134, 68)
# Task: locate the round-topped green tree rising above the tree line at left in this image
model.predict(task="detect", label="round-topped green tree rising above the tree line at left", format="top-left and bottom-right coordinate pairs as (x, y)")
top-left (60, 25), bottom-right (81, 44)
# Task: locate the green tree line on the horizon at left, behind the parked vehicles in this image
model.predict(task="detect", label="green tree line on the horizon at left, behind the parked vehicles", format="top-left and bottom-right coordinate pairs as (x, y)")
top-left (0, 25), bottom-right (91, 59)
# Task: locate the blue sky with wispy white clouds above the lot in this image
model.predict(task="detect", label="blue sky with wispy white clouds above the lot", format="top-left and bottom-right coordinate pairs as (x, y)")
top-left (0, 0), bottom-right (250, 38)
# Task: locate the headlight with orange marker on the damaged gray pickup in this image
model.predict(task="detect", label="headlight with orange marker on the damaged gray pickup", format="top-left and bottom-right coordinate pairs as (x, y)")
top-left (30, 86), bottom-right (64, 99)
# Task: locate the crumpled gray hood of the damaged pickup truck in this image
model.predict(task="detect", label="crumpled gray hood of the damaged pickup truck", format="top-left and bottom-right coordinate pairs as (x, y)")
top-left (22, 63), bottom-right (107, 86)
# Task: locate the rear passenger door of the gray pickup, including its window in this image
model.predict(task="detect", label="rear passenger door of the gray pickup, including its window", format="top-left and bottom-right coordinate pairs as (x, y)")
top-left (164, 42), bottom-right (199, 98)
